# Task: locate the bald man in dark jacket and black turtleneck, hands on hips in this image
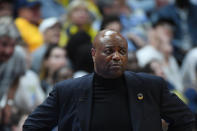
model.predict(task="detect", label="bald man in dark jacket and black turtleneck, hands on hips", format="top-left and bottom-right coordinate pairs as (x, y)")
top-left (23, 30), bottom-right (194, 131)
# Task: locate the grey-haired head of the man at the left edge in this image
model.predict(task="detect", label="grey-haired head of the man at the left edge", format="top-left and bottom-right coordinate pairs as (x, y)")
top-left (0, 17), bottom-right (19, 63)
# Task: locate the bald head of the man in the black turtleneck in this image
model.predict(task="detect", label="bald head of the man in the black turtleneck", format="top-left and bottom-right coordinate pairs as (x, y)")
top-left (92, 30), bottom-right (128, 78)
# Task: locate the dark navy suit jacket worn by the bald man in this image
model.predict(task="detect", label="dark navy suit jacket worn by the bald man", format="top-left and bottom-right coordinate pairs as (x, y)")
top-left (23, 72), bottom-right (194, 131)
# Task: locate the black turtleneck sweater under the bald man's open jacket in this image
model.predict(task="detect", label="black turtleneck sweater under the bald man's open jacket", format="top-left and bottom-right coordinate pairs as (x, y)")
top-left (90, 74), bottom-right (131, 131)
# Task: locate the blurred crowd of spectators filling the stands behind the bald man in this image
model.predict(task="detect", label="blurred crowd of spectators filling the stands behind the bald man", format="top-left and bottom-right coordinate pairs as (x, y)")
top-left (0, 0), bottom-right (197, 131)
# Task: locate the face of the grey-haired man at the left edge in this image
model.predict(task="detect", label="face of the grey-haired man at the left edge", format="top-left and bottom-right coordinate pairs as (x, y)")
top-left (0, 36), bottom-right (15, 63)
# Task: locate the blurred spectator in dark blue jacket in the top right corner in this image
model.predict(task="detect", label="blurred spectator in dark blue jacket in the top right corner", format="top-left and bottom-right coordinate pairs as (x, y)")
top-left (153, 0), bottom-right (197, 64)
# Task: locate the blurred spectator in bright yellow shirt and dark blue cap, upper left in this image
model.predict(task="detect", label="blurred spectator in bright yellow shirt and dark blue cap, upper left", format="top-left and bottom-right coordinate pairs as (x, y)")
top-left (15, 0), bottom-right (43, 52)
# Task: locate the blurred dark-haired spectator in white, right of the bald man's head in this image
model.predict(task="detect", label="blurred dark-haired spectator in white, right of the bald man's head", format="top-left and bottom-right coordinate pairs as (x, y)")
top-left (137, 19), bottom-right (183, 92)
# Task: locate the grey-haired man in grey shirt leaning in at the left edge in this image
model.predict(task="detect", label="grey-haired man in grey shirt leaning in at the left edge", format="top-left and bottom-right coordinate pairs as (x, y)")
top-left (0, 17), bottom-right (25, 131)
